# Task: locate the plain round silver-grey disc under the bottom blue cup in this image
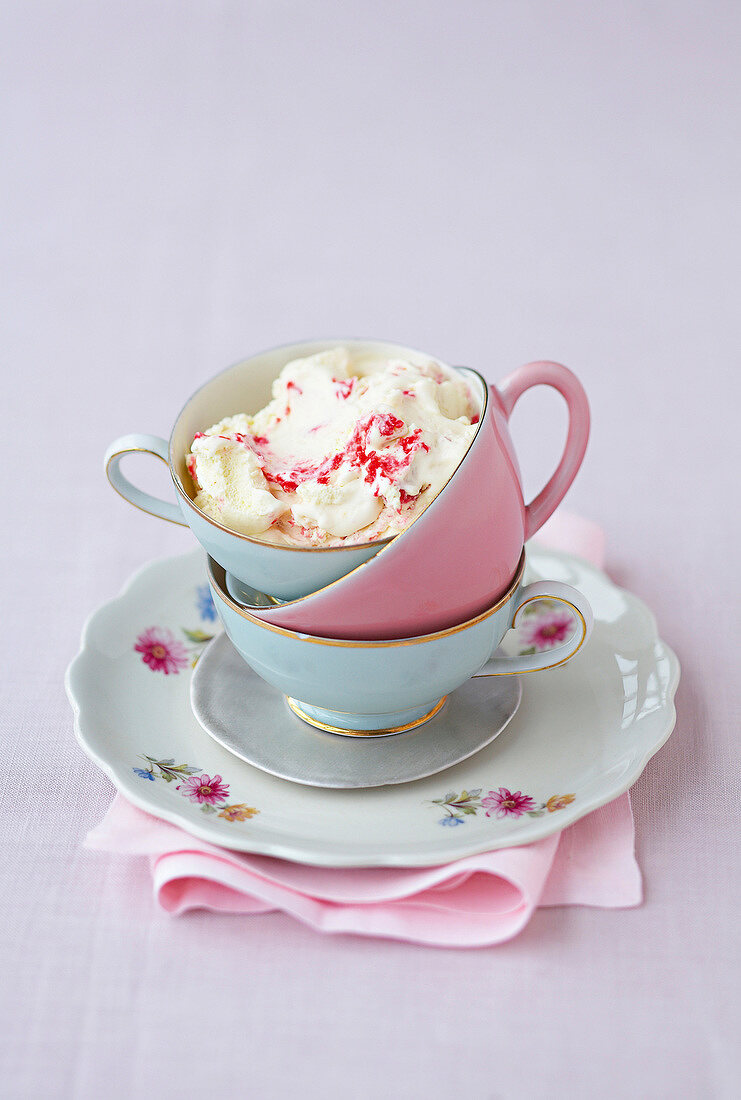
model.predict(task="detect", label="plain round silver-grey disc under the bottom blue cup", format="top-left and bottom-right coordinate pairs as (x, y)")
top-left (190, 634), bottom-right (522, 789)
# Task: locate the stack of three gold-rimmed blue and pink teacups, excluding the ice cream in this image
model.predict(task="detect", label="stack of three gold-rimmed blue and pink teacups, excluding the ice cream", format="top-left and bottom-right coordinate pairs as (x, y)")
top-left (106, 340), bottom-right (591, 735)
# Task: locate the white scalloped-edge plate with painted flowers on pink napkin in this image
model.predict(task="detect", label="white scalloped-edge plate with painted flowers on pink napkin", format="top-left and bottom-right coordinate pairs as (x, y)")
top-left (67, 547), bottom-right (679, 867)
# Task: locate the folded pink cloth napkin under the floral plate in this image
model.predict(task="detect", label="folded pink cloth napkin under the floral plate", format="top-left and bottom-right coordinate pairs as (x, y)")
top-left (86, 513), bottom-right (642, 947)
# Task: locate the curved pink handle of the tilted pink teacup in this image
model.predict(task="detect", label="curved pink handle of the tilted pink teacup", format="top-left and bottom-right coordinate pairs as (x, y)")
top-left (497, 360), bottom-right (589, 539)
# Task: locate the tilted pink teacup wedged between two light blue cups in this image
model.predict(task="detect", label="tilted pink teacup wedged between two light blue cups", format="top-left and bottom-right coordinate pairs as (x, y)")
top-left (219, 362), bottom-right (589, 640)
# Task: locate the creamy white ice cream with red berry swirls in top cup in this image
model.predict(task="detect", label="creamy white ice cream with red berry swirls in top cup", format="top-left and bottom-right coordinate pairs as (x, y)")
top-left (181, 348), bottom-right (478, 546)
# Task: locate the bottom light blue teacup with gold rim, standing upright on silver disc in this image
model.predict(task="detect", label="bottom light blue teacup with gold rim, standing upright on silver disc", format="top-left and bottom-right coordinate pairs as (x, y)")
top-left (208, 553), bottom-right (593, 736)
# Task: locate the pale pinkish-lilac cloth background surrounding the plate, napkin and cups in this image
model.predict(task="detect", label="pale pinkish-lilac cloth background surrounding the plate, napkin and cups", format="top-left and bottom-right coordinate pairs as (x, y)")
top-left (0, 0), bottom-right (741, 1098)
